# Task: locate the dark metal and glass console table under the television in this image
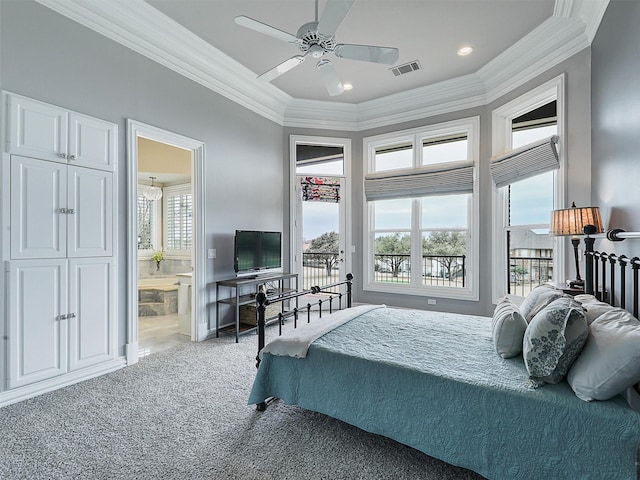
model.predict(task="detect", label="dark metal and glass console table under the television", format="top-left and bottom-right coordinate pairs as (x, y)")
top-left (216, 273), bottom-right (298, 343)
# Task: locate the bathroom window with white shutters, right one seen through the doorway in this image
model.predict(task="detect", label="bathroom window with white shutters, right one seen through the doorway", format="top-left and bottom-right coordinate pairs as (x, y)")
top-left (163, 184), bottom-right (193, 256)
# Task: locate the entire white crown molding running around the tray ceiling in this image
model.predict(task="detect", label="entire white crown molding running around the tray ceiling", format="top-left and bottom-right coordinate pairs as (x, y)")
top-left (36, 0), bottom-right (609, 131)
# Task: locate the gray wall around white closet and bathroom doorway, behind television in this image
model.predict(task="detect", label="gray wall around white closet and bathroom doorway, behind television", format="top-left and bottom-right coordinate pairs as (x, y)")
top-left (0, 0), bottom-right (284, 354)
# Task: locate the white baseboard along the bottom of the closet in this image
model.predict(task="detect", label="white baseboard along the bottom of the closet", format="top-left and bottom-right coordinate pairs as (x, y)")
top-left (0, 357), bottom-right (127, 408)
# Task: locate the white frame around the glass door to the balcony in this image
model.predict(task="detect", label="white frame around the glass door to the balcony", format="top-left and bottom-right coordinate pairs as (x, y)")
top-left (289, 135), bottom-right (354, 288)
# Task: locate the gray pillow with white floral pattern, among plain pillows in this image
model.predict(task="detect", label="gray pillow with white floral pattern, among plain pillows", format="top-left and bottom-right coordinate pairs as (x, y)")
top-left (522, 297), bottom-right (589, 385)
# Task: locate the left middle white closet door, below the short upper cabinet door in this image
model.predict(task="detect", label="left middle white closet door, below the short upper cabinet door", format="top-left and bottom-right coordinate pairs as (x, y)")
top-left (11, 155), bottom-right (68, 259)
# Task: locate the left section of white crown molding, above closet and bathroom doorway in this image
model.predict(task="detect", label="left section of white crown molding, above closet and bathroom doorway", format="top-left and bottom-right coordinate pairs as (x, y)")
top-left (36, 0), bottom-right (292, 124)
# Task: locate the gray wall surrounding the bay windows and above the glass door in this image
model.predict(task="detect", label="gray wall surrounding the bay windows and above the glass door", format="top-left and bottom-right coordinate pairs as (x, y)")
top-left (285, 49), bottom-right (591, 315)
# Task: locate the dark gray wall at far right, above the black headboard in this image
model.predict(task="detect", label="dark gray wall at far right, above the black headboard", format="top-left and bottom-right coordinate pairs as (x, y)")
top-left (591, 0), bottom-right (640, 256)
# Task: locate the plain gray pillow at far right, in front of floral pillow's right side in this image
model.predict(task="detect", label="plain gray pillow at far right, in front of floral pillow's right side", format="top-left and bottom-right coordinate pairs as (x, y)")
top-left (567, 307), bottom-right (640, 402)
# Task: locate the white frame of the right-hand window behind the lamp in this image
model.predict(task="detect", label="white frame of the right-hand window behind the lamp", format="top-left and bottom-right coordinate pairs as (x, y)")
top-left (491, 74), bottom-right (567, 303)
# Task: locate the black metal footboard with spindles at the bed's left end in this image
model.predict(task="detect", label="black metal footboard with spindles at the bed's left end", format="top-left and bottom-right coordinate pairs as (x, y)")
top-left (256, 273), bottom-right (353, 411)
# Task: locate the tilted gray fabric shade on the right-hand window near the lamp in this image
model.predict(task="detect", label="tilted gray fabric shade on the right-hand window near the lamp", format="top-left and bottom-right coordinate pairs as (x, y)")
top-left (490, 135), bottom-right (560, 187)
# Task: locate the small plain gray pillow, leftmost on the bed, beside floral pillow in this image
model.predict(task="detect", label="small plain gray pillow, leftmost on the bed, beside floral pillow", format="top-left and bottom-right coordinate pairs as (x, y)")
top-left (491, 297), bottom-right (527, 358)
